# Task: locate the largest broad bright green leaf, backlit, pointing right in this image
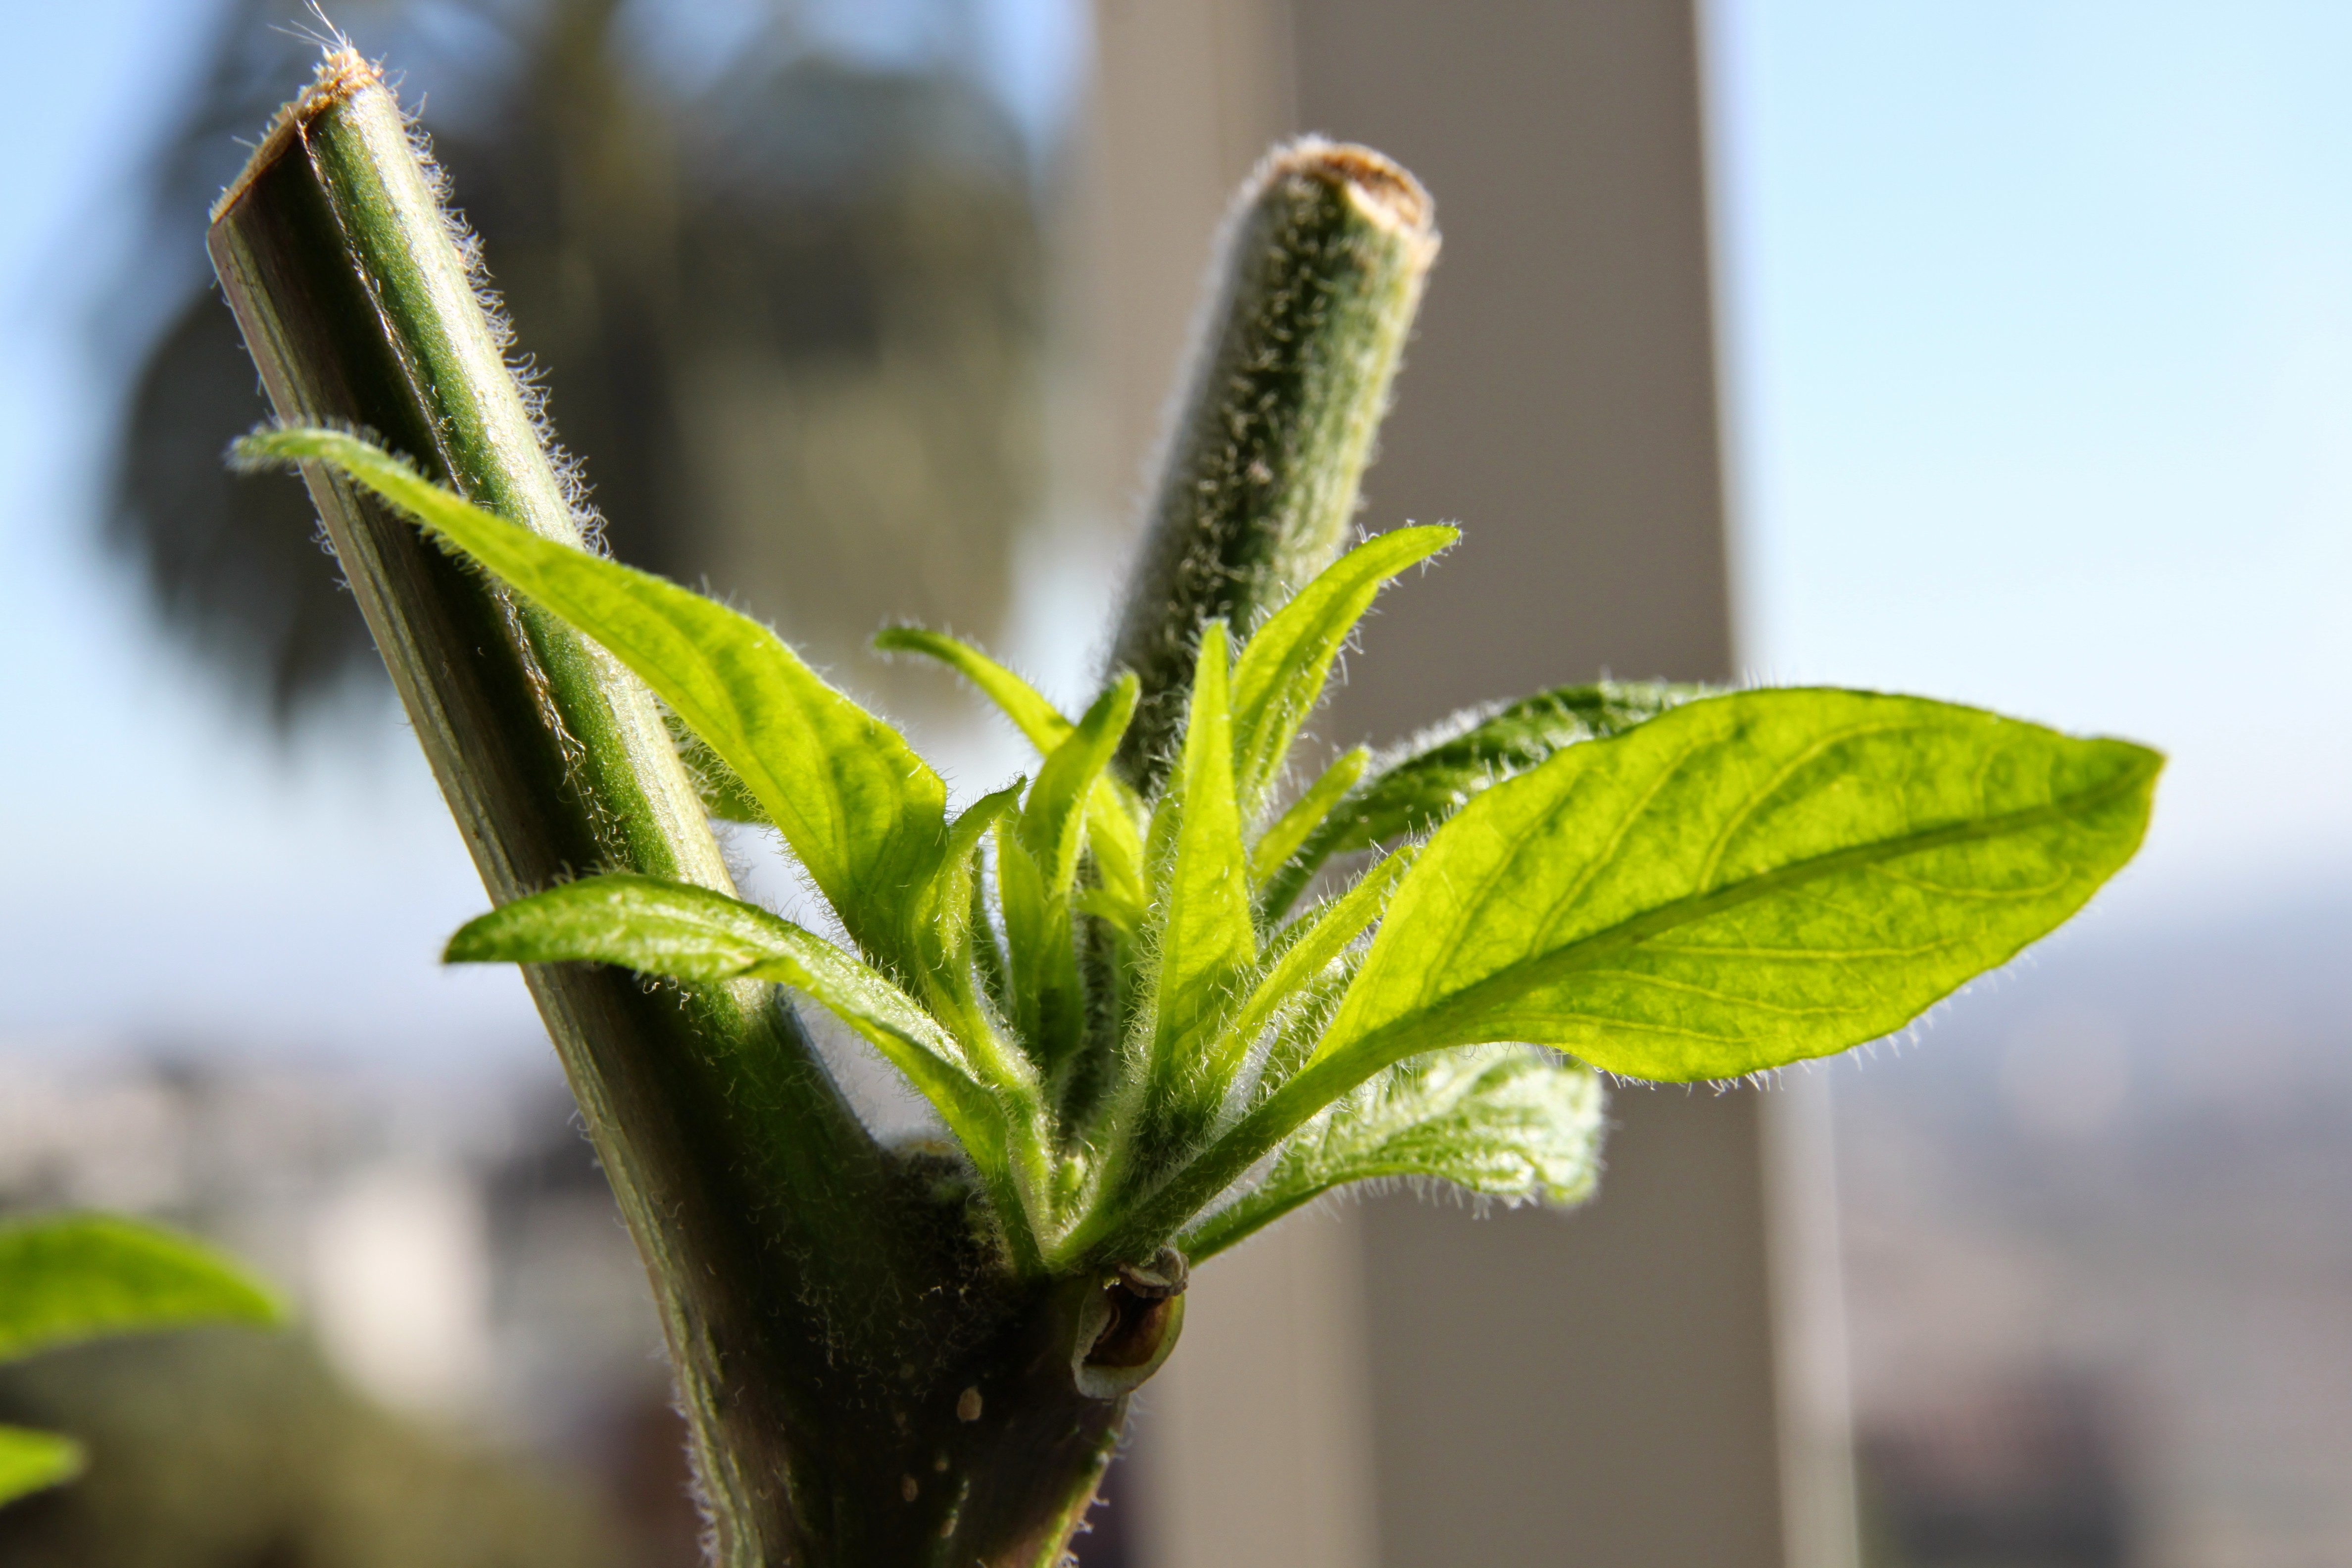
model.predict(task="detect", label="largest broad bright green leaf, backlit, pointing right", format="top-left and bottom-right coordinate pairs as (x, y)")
top-left (1301, 691), bottom-right (2161, 1084)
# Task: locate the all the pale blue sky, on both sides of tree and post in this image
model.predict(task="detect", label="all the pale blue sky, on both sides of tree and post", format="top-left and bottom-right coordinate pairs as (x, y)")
top-left (0, 0), bottom-right (2352, 1065)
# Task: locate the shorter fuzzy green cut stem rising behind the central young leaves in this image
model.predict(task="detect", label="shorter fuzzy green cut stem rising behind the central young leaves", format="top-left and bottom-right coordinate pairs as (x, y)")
top-left (1110, 139), bottom-right (1437, 790)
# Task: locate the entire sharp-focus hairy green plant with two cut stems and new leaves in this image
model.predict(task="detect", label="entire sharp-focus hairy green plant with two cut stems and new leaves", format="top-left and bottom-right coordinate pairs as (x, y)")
top-left (212, 51), bottom-right (2159, 1568)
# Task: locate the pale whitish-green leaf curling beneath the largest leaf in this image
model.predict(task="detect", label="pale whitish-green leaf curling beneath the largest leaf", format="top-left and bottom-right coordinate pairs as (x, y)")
top-left (1176, 1046), bottom-right (1607, 1265)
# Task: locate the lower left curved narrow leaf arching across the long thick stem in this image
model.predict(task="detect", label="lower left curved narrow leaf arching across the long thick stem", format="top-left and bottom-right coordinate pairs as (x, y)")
top-left (444, 875), bottom-right (1026, 1173)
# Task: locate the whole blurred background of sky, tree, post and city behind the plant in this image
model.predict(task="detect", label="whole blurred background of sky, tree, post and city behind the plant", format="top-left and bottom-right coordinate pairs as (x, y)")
top-left (0, 0), bottom-right (2352, 1568)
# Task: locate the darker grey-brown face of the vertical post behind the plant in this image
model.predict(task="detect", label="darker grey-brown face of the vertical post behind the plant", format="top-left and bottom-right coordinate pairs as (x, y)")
top-left (1294, 0), bottom-right (1811, 1568)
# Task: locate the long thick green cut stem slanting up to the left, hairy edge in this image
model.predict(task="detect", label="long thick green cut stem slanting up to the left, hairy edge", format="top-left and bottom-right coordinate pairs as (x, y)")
top-left (209, 51), bottom-right (1091, 1568)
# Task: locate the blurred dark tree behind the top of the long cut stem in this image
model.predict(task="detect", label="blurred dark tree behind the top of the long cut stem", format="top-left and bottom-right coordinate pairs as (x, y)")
top-left (110, 0), bottom-right (1044, 724)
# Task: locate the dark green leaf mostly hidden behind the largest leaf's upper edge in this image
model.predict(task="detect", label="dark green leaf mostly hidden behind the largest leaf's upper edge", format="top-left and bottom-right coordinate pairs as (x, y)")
top-left (1261, 682), bottom-right (1705, 917)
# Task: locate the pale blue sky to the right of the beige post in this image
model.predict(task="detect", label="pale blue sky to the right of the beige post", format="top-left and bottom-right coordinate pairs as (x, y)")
top-left (1710, 0), bottom-right (2352, 922)
